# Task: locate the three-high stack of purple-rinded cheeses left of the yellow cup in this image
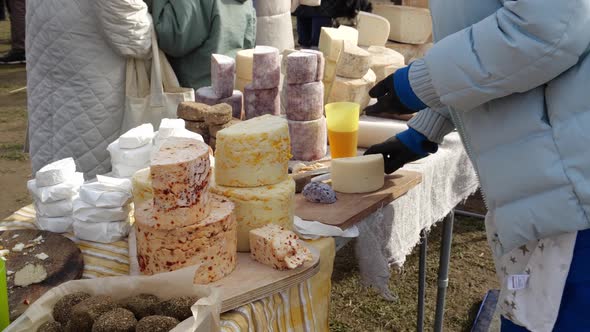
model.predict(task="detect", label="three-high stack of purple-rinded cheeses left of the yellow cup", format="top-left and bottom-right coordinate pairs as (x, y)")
top-left (286, 50), bottom-right (327, 161)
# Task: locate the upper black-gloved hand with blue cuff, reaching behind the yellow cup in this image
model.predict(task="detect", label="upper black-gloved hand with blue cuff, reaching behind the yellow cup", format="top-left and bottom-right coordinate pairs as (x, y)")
top-left (365, 66), bottom-right (427, 115)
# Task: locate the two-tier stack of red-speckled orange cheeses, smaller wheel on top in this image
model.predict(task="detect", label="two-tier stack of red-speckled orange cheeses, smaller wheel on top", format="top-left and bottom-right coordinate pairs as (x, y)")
top-left (133, 138), bottom-right (237, 283)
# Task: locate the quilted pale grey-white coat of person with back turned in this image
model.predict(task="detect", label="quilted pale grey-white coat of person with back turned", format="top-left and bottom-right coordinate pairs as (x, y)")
top-left (26, 0), bottom-right (152, 178)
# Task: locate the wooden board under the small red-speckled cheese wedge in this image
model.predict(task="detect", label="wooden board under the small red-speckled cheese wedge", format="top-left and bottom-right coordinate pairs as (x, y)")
top-left (209, 244), bottom-right (320, 312)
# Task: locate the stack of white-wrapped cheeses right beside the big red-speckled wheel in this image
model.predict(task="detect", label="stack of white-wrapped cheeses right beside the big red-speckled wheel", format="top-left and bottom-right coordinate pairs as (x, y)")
top-left (73, 175), bottom-right (132, 243)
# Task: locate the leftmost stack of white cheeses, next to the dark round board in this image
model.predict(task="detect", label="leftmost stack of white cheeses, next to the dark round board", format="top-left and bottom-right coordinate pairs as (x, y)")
top-left (27, 158), bottom-right (84, 233)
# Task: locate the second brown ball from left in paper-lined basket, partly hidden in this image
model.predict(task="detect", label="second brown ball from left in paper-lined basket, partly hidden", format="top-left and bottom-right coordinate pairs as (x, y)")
top-left (66, 295), bottom-right (118, 332)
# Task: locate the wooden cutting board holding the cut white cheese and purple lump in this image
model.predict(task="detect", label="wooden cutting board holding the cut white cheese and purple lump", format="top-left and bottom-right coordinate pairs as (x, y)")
top-left (295, 170), bottom-right (422, 229)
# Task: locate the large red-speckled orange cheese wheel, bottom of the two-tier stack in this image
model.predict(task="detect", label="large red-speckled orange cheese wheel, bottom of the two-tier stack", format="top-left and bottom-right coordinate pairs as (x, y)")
top-left (135, 195), bottom-right (237, 283)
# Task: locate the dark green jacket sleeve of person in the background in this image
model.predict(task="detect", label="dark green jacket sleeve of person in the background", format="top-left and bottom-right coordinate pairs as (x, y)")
top-left (152, 0), bottom-right (215, 57)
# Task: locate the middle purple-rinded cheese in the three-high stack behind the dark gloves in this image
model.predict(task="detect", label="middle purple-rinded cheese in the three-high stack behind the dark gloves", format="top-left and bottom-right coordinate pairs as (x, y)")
top-left (286, 82), bottom-right (324, 121)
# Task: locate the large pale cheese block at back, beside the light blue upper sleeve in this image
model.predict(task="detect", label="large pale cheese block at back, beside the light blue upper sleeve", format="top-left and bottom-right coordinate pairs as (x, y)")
top-left (373, 4), bottom-right (432, 44)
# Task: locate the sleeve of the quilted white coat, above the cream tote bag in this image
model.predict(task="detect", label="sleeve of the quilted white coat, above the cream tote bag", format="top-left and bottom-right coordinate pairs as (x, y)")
top-left (92, 0), bottom-right (152, 58)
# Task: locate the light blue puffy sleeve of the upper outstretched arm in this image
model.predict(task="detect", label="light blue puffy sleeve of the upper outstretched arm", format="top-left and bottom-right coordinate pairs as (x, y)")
top-left (410, 0), bottom-right (590, 111)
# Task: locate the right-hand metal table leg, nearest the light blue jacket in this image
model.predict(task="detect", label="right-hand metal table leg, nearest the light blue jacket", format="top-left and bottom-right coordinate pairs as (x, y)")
top-left (434, 211), bottom-right (455, 332)
